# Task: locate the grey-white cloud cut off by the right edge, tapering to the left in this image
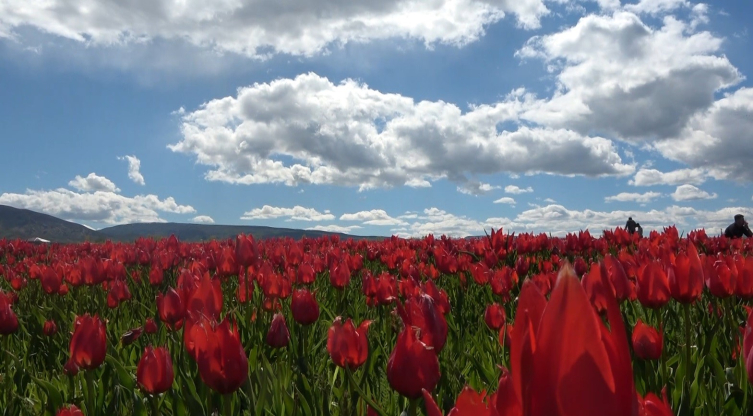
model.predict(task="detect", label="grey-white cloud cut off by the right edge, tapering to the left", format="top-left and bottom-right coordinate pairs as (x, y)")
top-left (654, 88), bottom-right (753, 182)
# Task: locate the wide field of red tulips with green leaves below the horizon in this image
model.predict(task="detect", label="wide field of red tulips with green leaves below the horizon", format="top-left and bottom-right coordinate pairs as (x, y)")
top-left (0, 227), bottom-right (753, 416)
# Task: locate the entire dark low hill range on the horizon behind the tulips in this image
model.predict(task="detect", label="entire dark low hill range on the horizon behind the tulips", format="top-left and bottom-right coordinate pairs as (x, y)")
top-left (0, 205), bottom-right (386, 243)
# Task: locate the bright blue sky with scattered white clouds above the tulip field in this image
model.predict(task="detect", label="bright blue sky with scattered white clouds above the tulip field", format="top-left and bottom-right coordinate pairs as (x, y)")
top-left (0, 0), bottom-right (753, 237)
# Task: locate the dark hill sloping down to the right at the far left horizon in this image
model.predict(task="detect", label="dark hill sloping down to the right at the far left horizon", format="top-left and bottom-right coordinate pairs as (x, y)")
top-left (0, 205), bottom-right (100, 243)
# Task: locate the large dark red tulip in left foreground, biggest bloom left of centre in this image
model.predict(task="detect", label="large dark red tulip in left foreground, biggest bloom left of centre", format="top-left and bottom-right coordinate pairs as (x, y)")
top-left (195, 318), bottom-right (248, 394)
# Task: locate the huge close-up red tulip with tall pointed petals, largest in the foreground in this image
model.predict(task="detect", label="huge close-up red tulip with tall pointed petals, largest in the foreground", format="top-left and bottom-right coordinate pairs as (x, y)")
top-left (510, 264), bottom-right (638, 416)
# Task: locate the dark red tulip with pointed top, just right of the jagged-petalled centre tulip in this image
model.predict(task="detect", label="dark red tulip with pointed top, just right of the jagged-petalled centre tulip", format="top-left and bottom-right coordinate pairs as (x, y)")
top-left (387, 323), bottom-right (440, 399)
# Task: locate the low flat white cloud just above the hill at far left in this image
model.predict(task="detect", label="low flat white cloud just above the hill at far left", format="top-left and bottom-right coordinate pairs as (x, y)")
top-left (0, 188), bottom-right (196, 224)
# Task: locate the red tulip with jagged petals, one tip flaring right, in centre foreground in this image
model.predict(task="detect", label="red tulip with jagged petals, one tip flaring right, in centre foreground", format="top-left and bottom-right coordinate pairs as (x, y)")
top-left (327, 316), bottom-right (372, 370)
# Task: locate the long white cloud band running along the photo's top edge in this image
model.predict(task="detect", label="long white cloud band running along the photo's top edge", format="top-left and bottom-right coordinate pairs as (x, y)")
top-left (0, 0), bottom-right (549, 57)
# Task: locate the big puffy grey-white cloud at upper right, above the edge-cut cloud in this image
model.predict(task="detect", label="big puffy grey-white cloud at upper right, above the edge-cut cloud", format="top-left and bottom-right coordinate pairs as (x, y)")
top-left (517, 10), bottom-right (743, 143)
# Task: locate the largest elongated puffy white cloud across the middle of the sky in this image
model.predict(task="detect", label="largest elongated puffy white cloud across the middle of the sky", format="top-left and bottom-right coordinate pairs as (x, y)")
top-left (169, 73), bottom-right (635, 190)
